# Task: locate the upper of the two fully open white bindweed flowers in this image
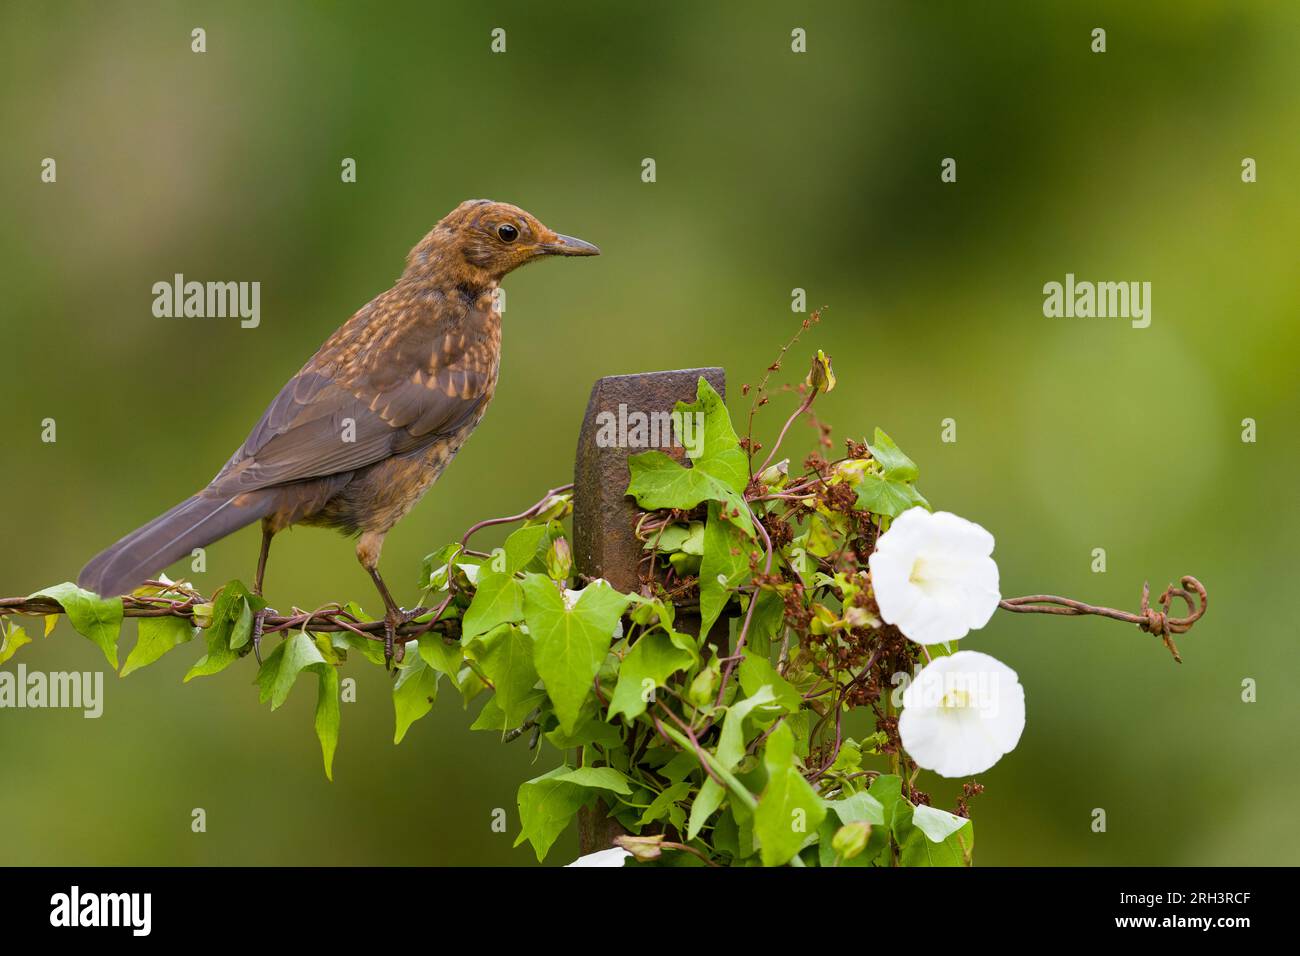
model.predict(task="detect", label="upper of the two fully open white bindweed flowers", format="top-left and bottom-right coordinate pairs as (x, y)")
top-left (867, 507), bottom-right (1002, 644)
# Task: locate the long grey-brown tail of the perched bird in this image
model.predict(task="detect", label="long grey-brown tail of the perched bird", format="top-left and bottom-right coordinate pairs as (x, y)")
top-left (77, 492), bottom-right (272, 597)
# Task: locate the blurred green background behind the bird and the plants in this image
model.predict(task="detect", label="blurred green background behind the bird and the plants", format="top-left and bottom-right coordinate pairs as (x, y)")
top-left (0, 0), bottom-right (1300, 865)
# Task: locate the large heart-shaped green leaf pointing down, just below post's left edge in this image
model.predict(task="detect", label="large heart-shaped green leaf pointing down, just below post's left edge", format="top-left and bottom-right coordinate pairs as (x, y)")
top-left (523, 575), bottom-right (629, 734)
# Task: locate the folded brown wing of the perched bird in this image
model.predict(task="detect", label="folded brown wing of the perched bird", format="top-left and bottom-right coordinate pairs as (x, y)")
top-left (211, 343), bottom-right (495, 494)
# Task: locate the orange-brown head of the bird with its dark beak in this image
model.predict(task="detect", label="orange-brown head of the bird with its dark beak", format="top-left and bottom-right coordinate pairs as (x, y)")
top-left (407, 199), bottom-right (601, 284)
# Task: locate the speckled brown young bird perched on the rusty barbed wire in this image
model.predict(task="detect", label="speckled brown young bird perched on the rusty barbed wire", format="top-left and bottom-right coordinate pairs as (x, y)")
top-left (77, 199), bottom-right (601, 663)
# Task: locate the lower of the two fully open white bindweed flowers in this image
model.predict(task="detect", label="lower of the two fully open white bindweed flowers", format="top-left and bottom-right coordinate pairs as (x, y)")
top-left (898, 650), bottom-right (1024, 777)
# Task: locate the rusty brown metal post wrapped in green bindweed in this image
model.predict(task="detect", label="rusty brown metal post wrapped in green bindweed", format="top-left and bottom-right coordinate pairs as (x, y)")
top-left (573, 368), bottom-right (727, 853)
